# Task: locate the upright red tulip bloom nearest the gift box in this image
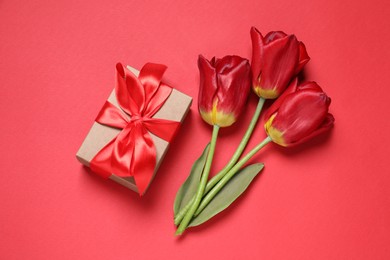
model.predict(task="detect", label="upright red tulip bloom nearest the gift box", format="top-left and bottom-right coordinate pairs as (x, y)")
top-left (198, 55), bottom-right (251, 127)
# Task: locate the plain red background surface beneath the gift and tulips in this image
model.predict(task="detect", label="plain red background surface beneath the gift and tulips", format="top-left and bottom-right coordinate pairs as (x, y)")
top-left (0, 0), bottom-right (390, 259)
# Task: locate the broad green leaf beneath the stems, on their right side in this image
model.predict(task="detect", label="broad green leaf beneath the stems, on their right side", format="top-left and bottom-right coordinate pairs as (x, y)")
top-left (189, 163), bottom-right (264, 227)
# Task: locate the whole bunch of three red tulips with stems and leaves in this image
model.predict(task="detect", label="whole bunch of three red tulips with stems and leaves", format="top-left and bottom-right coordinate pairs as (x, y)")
top-left (174, 27), bottom-right (334, 235)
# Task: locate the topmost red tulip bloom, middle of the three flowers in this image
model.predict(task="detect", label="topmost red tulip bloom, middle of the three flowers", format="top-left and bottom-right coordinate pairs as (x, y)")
top-left (251, 27), bottom-right (310, 99)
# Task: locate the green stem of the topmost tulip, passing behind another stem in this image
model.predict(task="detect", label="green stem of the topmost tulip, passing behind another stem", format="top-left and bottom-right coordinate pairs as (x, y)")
top-left (175, 98), bottom-right (265, 226)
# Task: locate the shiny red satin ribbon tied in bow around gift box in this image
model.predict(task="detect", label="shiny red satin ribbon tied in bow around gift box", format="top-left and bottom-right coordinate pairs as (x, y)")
top-left (90, 63), bottom-right (180, 195)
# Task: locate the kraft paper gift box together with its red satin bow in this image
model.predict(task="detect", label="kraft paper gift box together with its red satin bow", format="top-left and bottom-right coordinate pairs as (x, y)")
top-left (76, 63), bottom-right (192, 195)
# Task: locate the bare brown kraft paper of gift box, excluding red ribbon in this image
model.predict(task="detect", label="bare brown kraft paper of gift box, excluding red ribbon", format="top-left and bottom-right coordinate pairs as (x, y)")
top-left (76, 66), bottom-right (192, 195)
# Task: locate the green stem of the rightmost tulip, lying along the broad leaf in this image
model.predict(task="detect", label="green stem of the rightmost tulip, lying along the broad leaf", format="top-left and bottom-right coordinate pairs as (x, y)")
top-left (194, 136), bottom-right (272, 216)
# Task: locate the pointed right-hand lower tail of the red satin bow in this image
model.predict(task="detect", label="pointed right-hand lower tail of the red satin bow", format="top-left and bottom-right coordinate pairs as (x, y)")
top-left (131, 126), bottom-right (156, 196)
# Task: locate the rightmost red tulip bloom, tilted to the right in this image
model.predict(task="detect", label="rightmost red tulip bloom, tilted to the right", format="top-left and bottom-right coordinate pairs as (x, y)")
top-left (265, 79), bottom-right (334, 146)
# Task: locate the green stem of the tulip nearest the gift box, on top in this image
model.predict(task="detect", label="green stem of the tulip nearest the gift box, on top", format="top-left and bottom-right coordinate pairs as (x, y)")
top-left (176, 125), bottom-right (219, 235)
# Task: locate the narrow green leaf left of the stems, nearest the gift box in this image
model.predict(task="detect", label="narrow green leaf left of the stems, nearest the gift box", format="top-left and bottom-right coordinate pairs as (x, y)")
top-left (173, 143), bottom-right (210, 217)
